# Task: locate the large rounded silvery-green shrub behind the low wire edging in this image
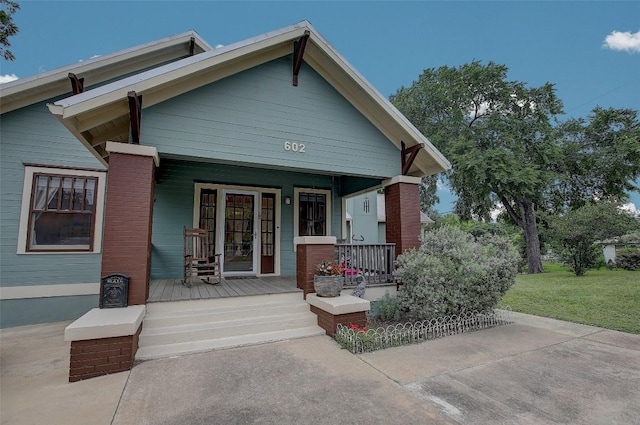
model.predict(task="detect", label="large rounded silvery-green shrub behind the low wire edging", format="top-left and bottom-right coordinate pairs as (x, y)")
top-left (397, 226), bottom-right (519, 321)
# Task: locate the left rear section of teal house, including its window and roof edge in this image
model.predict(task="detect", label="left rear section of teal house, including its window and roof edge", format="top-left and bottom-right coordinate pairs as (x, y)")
top-left (0, 31), bottom-right (211, 328)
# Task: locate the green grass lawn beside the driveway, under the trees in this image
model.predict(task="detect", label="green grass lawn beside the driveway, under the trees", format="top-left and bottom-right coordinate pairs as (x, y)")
top-left (500, 264), bottom-right (640, 334)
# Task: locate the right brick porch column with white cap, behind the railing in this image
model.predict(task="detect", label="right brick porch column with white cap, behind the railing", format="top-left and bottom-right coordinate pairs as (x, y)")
top-left (383, 176), bottom-right (420, 255)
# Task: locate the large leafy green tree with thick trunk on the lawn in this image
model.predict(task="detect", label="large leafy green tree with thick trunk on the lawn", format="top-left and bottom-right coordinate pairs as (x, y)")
top-left (391, 61), bottom-right (640, 273)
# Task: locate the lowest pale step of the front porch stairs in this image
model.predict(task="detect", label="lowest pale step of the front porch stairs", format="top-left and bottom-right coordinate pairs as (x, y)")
top-left (136, 325), bottom-right (325, 360)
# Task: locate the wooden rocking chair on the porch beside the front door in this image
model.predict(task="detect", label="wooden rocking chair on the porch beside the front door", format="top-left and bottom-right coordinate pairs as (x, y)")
top-left (182, 228), bottom-right (222, 288)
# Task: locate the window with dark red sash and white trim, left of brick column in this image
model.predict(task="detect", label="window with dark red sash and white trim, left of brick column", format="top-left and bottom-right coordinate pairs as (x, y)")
top-left (18, 166), bottom-right (105, 253)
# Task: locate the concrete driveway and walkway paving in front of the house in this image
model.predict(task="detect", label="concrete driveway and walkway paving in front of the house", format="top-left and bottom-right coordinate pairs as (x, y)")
top-left (0, 313), bottom-right (640, 425)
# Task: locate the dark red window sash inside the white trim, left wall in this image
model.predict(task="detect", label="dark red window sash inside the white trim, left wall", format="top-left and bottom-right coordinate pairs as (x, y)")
top-left (27, 173), bottom-right (98, 251)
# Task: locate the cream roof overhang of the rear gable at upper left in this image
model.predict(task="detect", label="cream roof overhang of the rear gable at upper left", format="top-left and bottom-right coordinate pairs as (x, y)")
top-left (0, 31), bottom-right (213, 114)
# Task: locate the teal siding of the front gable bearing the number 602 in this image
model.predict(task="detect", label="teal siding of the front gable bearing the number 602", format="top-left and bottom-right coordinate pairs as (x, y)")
top-left (141, 57), bottom-right (400, 178)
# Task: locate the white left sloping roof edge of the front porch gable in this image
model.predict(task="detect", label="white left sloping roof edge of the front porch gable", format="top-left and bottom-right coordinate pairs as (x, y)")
top-left (50, 26), bottom-right (307, 119)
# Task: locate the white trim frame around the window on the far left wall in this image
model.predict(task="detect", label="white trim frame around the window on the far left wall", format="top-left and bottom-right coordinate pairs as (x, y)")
top-left (16, 165), bottom-right (107, 255)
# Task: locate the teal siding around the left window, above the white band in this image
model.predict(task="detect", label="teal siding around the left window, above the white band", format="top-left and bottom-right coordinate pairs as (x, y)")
top-left (0, 103), bottom-right (104, 290)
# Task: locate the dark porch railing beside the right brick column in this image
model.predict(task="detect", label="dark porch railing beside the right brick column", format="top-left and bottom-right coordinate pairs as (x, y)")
top-left (334, 243), bottom-right (396, 285)
